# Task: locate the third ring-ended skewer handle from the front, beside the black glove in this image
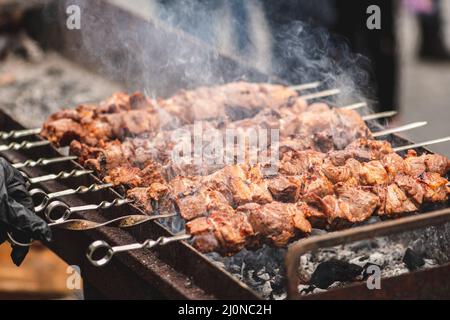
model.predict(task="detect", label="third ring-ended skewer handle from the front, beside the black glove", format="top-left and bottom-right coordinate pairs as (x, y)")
top-left (30, 183), bottom-right (113, 213)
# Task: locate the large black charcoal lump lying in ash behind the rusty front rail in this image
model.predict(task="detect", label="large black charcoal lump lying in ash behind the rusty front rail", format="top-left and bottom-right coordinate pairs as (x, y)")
top-left (309, 259), bottom-right (363, 289)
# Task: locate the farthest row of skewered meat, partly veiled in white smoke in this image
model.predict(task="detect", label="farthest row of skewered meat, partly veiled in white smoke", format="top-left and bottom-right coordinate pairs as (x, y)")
top-left (41, 82), bottom-right (306, 146)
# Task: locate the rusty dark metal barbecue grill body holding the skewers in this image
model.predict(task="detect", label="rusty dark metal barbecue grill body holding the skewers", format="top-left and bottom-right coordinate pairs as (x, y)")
top-left (0, 0), bottom-right (450, 299)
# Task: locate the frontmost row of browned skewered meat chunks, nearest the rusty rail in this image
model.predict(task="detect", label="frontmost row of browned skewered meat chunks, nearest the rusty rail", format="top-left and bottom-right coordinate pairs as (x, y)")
top-left (182, 148), bottom-right (450, 254)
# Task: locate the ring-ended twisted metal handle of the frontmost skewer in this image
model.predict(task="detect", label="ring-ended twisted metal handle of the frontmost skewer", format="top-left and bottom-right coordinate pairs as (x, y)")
top-left (86, 234), bottom-right (191, 267)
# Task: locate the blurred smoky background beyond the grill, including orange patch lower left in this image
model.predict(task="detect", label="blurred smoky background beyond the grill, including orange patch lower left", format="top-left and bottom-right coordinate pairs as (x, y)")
top-left (0, 0), bottom-right (450, 299)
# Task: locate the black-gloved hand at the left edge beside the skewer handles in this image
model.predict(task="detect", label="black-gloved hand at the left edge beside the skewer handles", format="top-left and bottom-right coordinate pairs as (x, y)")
top-left (0, 158), bottom-right (52, 266)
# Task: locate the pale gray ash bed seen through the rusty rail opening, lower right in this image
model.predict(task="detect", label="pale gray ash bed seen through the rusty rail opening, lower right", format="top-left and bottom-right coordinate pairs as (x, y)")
top-left (299, 223), bottom-right (450, 294)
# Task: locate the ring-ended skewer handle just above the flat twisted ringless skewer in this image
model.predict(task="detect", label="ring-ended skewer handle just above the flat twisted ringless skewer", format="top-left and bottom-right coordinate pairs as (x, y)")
top-left (44, 198), bottom-right (133, 222)
